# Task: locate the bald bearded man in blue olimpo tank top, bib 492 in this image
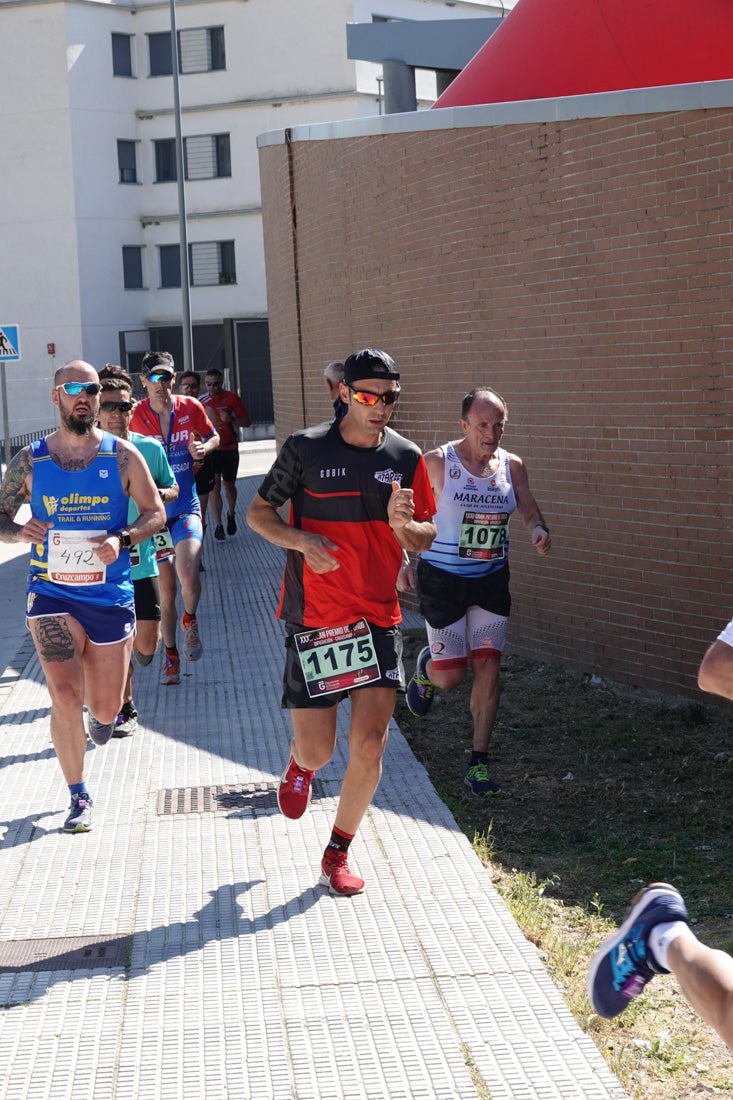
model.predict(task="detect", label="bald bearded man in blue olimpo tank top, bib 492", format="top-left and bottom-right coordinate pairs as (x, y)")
top-left (0, 360), bottom-right (165, 833)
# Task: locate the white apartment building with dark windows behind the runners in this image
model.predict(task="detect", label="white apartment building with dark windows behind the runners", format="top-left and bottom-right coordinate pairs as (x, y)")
top-left (0, 0), bottom-right (501, 437)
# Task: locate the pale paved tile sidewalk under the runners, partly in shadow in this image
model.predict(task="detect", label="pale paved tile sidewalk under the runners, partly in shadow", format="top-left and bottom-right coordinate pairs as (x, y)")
top-left (0, 459), bottom-right (625, 1100)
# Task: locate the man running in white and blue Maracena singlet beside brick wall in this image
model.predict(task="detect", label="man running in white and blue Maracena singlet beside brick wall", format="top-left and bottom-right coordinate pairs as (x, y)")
top-left (407, 386), bottom-right (551, 795)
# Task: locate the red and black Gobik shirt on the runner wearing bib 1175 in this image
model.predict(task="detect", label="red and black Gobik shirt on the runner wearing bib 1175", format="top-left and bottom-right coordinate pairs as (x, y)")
top-left (259, 421), bottom-right (436, 627)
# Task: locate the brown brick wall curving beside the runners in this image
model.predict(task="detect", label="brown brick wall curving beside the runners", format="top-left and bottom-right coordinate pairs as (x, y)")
top-left (256, 109), bottom-right (733, 693)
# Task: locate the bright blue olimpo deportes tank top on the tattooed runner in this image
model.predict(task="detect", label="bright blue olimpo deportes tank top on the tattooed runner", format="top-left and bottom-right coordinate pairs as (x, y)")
top-left (28, 432), bottom-right (134, 607)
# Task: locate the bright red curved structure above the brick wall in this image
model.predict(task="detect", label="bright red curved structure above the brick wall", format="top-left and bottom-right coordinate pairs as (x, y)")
top-left (434, 0), bottom-right (733, 108)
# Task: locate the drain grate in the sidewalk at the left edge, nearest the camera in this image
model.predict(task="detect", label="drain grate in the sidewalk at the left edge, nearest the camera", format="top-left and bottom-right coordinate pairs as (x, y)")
top-left (0, 936), bottom-right (132, 974)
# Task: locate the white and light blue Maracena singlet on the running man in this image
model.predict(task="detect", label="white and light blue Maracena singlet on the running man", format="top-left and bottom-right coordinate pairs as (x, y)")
top-left (420, 443), bottom-right (516, 576)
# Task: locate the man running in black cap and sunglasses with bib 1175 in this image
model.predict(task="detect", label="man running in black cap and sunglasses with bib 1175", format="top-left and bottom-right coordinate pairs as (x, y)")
top-left (248, 348), bottom-right (436, 894)
